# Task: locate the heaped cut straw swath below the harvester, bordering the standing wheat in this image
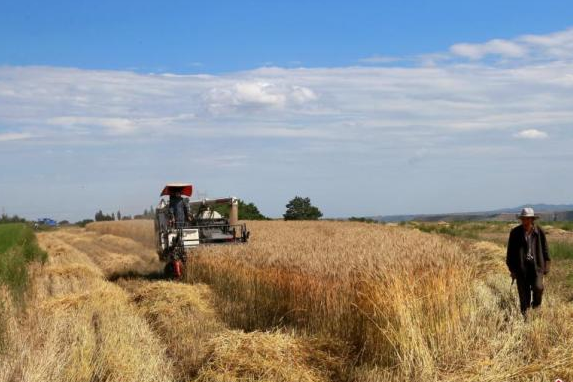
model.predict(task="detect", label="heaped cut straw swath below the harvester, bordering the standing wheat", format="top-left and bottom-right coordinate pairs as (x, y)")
top-left (119, 280), bottom-right (342, 382)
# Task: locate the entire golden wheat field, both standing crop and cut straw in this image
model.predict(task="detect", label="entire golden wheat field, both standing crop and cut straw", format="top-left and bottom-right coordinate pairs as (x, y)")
top-left (0, 221), bottom-right (573, 382)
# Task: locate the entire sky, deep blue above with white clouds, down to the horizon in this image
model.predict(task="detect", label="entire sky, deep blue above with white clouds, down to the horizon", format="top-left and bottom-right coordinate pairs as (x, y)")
top-left (0, 1), bottom-right (573, 220)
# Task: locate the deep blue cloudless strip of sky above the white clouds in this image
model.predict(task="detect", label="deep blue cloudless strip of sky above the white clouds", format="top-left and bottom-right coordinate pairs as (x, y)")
top-left (0, 0), bottom-right (573, 73)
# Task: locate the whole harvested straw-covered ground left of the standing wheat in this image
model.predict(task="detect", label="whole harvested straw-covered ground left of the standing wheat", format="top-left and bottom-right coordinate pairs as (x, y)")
top-left (0, 230), bottom-right (341, 382)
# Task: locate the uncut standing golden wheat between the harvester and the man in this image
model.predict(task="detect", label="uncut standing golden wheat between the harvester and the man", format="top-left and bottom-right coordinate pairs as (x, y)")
top-left (66, 222), bottom-right (573, 382)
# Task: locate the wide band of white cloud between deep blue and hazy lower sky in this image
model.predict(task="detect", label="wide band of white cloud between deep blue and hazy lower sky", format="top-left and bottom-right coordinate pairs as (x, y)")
top-left (0, 26), bottom-right (573, 152)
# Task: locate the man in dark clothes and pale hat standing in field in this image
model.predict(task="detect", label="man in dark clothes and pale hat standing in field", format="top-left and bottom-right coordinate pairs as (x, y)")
top-left (506, 208), bottom-right (551, 317)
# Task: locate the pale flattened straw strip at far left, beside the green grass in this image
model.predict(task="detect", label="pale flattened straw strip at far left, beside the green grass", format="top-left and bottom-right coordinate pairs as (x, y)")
top-left (2, 234), bottom-right (172, 382)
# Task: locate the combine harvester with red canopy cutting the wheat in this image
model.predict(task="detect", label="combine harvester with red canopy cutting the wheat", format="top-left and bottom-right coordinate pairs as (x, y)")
top-left (155, 183), bottom-right (249, 279)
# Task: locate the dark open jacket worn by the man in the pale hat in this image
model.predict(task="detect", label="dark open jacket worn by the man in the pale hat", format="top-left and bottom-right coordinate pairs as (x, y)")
top-left (505, 225), bottom-right (551, 277)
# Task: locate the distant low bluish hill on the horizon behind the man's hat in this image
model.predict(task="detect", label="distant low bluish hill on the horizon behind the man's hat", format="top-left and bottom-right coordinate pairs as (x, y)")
top-left (369, 203), bottom-right (573, 222)
